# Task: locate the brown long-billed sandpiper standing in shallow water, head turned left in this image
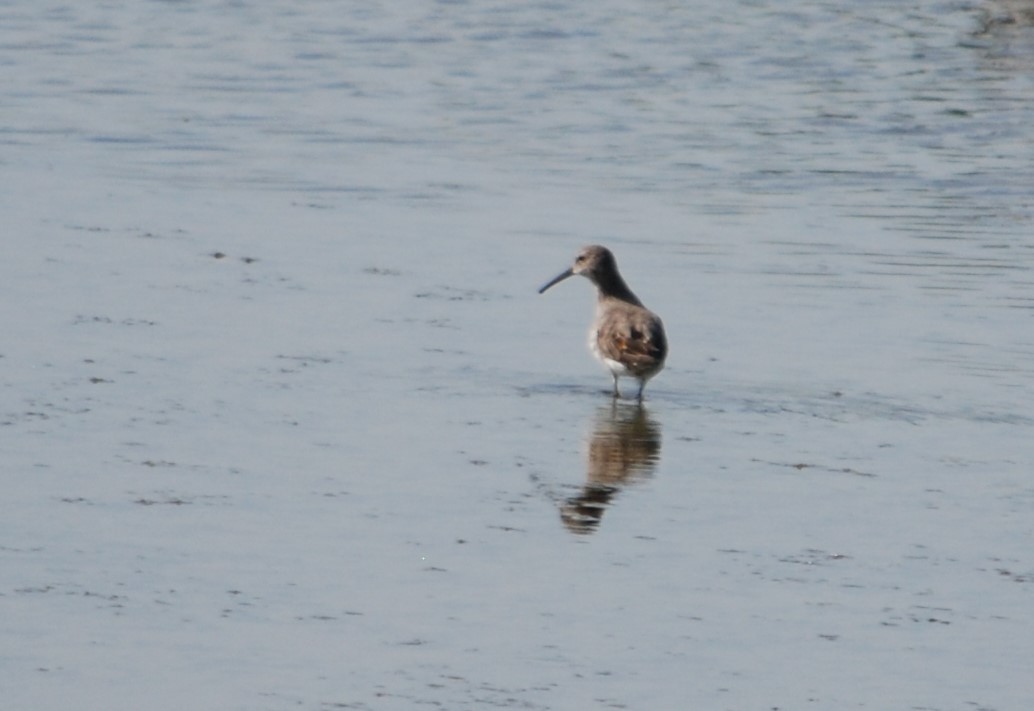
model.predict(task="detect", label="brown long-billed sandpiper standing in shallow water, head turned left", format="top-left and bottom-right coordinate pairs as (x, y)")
top-left (539, 245), bottom-right (668, 401)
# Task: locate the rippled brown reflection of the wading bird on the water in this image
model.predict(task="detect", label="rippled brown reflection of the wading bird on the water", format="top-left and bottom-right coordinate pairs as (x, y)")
top-left (560, 400), bottom-right (661, 534)
